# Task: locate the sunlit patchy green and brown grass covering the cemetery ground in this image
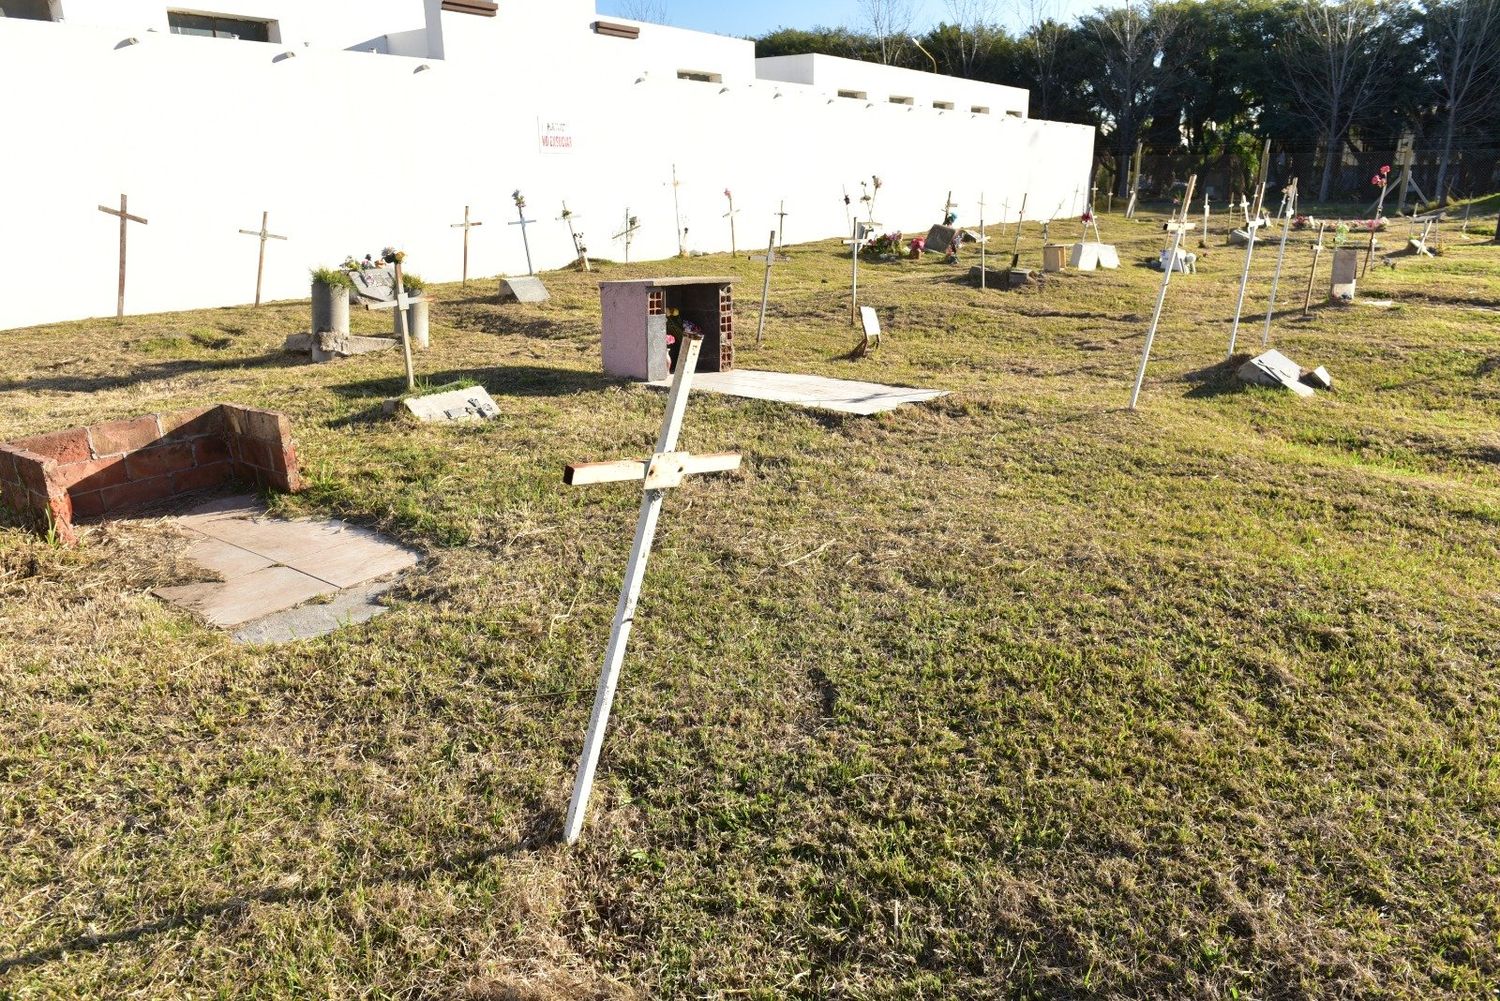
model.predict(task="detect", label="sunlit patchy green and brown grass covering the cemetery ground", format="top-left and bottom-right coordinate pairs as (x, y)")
top-left (0, 204), bottom-right (1500, 1001)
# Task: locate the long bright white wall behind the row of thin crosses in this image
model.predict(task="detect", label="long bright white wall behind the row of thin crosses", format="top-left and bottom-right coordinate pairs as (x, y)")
top-left (0, 8), bottom-right (1094, 329)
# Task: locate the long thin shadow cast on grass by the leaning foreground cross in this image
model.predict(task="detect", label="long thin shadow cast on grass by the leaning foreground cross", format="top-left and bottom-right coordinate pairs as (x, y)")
top-left (0, 810), bottom-right (563, 975)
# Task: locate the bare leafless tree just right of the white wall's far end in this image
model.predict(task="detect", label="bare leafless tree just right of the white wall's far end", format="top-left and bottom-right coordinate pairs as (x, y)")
top-left (1080, 0), bottom-right (1176, 197)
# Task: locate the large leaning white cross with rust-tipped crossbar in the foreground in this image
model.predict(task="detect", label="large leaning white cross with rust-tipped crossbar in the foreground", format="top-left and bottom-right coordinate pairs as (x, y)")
top-left (563, 335), bottom-right (740, 845)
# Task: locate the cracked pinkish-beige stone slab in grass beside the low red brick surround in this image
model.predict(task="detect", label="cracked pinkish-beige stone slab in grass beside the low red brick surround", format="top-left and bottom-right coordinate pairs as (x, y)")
top-left (156, 497), bottom-right (419, 642)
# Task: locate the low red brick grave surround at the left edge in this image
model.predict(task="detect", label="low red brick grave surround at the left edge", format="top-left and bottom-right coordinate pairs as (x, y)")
top-left (0, 404), bottom-right (302, 545)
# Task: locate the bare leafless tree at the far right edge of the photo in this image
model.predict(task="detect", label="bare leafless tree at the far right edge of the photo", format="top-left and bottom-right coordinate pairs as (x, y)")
top-left (1422, 0), bottom-right (1500, 198)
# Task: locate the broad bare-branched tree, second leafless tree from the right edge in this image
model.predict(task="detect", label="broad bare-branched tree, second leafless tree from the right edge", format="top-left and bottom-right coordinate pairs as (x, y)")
top-left (1278, 0), bottom-right (1397, 201)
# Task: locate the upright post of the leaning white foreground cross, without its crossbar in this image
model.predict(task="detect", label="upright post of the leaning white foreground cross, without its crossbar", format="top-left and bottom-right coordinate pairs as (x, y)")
top-left (564, 338), bottom-right (704, 845)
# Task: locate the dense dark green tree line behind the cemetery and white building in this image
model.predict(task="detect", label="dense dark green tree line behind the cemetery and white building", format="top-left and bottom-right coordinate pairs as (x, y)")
top-left (756, 0), bottom-right (1500, 203)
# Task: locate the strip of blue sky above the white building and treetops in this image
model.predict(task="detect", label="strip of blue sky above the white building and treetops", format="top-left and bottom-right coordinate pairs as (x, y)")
top-left (599, 0), bottom-right (1103, 35)
